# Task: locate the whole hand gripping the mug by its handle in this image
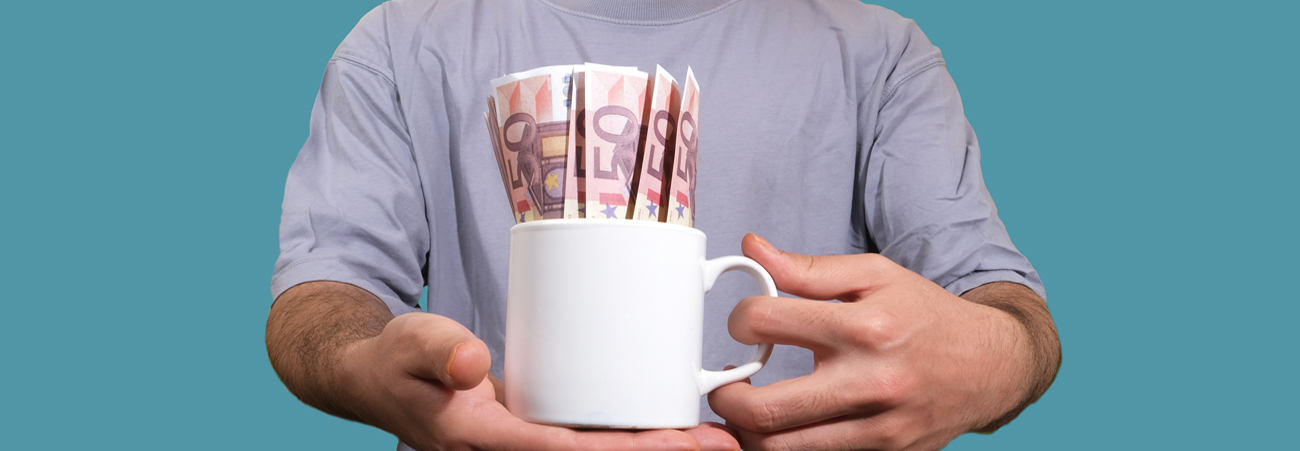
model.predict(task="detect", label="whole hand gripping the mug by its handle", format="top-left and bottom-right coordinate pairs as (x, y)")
top-left (709, 235), bottom-right (1060, 451)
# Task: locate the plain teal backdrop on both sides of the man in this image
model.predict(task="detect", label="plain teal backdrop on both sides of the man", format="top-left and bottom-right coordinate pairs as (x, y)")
top-left (0, 0), bottom-right (1300, 450)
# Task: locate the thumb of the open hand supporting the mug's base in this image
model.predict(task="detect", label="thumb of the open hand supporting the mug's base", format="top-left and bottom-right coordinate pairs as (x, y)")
top-left (384, 313), bottom-right (491, 390)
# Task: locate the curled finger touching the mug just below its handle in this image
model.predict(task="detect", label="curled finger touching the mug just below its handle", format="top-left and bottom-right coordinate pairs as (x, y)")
top-left (709, 370), bottom-right (866, 433)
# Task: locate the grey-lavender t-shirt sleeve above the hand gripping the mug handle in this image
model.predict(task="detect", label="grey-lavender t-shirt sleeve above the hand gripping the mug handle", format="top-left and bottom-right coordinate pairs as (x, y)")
top-left (862, 25), bottom-right (1047, 299)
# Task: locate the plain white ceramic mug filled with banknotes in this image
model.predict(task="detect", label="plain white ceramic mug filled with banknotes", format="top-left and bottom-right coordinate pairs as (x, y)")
top-left (504, 220), bottom-right (776, 429)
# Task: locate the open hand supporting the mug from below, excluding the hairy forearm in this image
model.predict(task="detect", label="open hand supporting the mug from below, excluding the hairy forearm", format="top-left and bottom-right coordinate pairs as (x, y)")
top-left (337, 313), bottom-right (740, 451)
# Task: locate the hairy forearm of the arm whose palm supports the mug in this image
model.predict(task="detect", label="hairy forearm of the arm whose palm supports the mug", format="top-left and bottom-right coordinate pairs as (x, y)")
top-left (267, 281), bottom-right (393, 421)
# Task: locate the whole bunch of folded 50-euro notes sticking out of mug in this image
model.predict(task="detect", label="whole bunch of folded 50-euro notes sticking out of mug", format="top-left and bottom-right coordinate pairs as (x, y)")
top-left (485, 62), bottom-right (699, 226)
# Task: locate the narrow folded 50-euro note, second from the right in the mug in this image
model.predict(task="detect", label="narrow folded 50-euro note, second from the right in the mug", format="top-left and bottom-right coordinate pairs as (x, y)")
top-left (632, 65), bottom-right (681, 221)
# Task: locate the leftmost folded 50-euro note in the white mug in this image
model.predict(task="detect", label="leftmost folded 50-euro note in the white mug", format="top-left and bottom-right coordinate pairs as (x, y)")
top-left (491, 66), bottom-right (573, 222)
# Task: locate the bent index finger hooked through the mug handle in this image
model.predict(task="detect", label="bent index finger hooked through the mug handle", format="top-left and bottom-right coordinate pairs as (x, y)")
top-left (727, 296), bottom-right (848, 354)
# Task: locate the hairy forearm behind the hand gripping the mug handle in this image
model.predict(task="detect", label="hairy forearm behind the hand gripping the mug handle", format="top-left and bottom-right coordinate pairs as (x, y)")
top-left (962, 282), bottom-right (1061, 433)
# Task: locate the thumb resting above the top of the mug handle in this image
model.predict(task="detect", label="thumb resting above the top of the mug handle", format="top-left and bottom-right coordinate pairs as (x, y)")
top-left (741, 234), bottom-right (902, 302)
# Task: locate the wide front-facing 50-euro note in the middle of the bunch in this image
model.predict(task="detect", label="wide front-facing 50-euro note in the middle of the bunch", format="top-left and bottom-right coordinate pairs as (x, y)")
top-left (582, 64), bottom-right (649, 220)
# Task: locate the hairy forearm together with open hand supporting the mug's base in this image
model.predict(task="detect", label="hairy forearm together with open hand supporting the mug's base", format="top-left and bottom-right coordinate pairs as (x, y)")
top-left (267, 282), bottom-right (740, 451)
